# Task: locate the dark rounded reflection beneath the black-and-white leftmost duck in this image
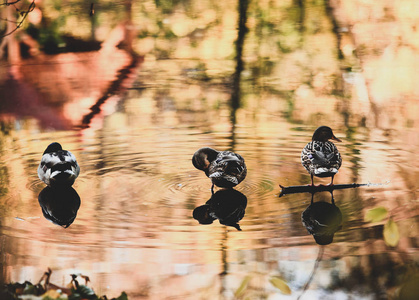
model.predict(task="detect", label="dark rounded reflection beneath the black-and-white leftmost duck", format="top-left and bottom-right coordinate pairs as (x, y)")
top-left (38, 186), bottom-right (80, 228)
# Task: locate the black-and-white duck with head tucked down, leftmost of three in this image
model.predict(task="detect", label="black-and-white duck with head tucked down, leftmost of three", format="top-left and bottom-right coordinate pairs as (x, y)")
top-left (38, 142), bottom-right (80, 187)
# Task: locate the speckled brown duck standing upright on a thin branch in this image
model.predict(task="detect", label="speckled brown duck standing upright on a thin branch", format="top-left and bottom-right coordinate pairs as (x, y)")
top-left (301, 126), bottom-right (342, 186)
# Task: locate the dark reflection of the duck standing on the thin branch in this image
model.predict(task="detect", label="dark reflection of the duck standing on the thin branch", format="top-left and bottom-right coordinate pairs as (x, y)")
top-left (301, 193), bottom-right (342, 245)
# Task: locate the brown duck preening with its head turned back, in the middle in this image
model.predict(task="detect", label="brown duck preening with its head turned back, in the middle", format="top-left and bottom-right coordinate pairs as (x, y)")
top-left (192, 147), bottom-right (247, 192)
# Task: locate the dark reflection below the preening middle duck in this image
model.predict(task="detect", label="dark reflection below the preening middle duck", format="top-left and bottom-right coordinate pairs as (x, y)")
top-left (193, 189), bottom-right (247, 231)
